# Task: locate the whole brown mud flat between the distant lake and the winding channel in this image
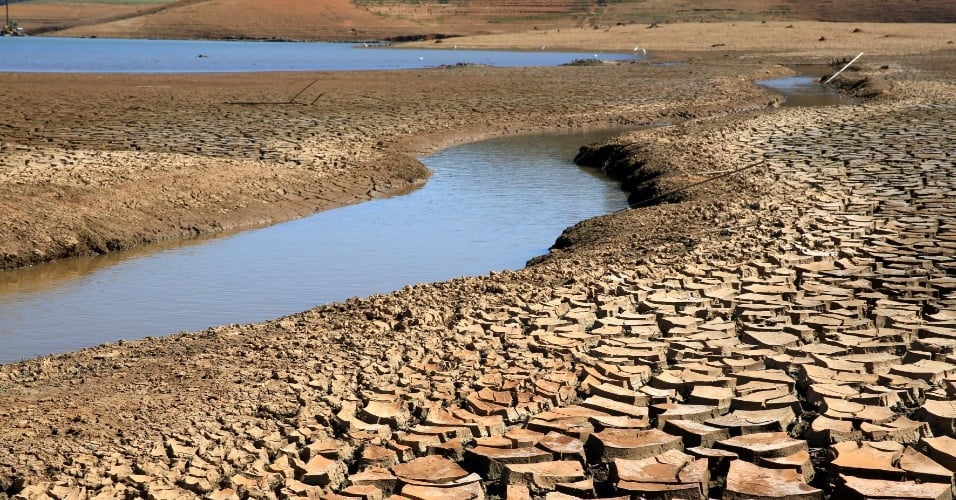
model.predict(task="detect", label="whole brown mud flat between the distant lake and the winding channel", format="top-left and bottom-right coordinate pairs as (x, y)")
top-left (0, 64), bottom-right (775, 268)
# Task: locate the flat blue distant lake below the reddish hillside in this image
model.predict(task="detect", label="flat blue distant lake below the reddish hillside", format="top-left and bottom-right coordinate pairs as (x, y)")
top-left (0, 37), bottom-right (635, 73)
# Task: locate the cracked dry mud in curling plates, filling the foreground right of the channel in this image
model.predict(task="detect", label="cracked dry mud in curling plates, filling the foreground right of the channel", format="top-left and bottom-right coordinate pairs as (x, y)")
top-left (0, 24), bottom-right (956, 499)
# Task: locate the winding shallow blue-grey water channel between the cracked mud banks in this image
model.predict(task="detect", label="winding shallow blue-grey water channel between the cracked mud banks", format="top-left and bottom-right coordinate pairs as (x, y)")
top-left (0, 130), bottom-right (627, 363)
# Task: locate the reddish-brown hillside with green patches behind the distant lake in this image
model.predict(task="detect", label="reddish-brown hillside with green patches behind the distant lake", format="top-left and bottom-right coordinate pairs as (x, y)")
top-left (10, 0), bottom-right (956, 40)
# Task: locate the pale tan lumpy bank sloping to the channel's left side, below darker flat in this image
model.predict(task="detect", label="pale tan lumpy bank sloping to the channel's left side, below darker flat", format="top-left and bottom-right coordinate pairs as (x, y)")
top-left (0, 145), bottom-right (429, 268)
